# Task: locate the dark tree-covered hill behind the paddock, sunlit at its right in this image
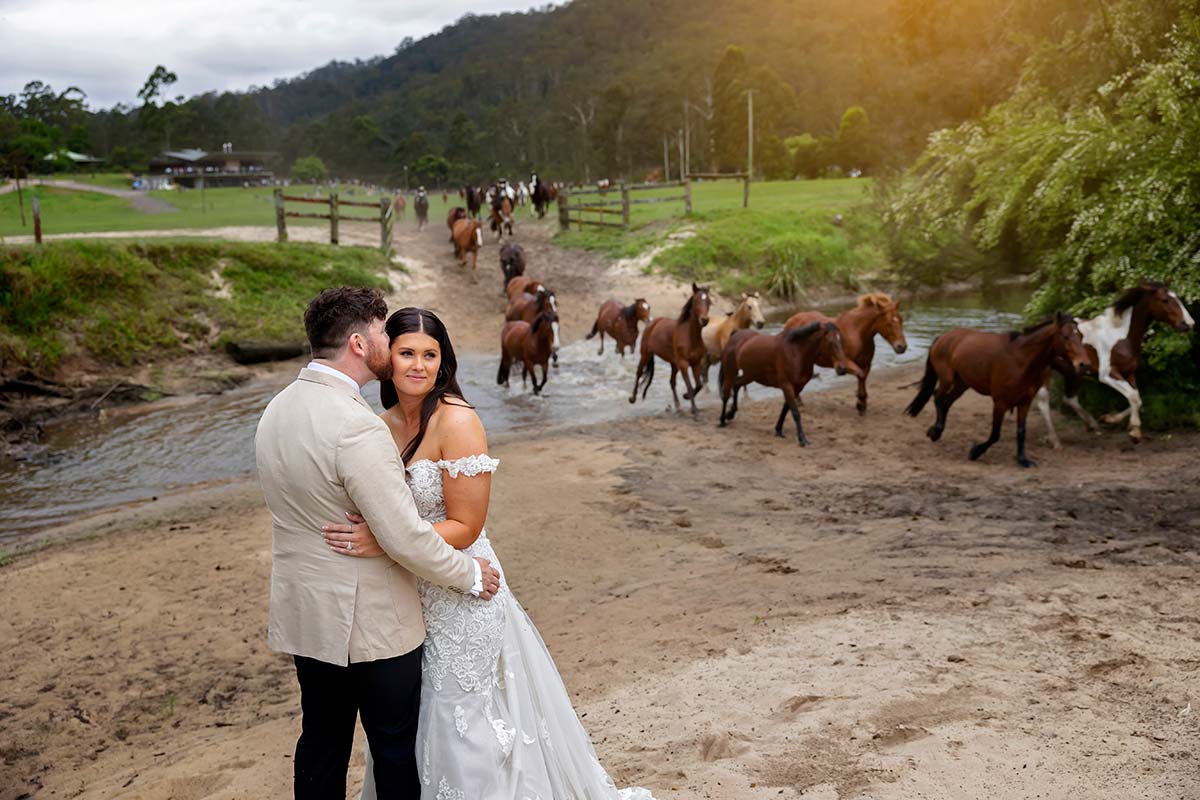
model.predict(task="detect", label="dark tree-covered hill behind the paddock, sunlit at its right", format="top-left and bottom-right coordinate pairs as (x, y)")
top-left (14, 0), bottom-right (1092, 181)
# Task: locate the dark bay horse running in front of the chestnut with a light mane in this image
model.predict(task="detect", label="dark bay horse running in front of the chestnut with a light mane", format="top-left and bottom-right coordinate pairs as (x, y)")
top-left (718, 321), bottom-right (851, 447)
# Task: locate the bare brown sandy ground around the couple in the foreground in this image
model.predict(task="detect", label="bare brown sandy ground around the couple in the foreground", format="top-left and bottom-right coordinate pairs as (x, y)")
top-left (0, 367), bottom-right (1200, 800)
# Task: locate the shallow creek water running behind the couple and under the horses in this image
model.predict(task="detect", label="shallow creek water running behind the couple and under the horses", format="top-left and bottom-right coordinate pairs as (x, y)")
top-left (0, 293), bottom-right (1026, 546)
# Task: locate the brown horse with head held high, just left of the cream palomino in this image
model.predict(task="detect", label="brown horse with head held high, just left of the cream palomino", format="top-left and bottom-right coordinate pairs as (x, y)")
top-left (629, 283), bottom-right (709, 416)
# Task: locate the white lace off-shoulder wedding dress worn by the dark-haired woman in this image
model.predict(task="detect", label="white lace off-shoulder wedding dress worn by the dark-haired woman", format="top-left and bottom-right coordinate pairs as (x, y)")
top-left (362, 455), bottom-right (654, 800)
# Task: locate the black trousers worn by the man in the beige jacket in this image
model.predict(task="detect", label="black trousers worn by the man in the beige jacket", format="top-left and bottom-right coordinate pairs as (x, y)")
top-left (294, 648), bottom-right (421, 800)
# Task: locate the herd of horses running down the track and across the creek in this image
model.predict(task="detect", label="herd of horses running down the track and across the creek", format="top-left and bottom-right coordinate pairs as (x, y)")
top-left (417, 182), bottom-right (1195, 467)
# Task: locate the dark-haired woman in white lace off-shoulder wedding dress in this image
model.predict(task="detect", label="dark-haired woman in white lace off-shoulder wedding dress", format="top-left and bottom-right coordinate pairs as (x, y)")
top-left (325, 308), bottom-right (653, 800)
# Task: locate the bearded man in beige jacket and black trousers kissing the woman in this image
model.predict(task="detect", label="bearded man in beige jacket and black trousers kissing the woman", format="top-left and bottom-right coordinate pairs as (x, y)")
top-left (254, 288), bottom-right (499, 800)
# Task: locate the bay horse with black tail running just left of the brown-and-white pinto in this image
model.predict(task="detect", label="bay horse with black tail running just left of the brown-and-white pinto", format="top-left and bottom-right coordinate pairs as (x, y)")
top-left (905, 312), bottom-right (1091, 467)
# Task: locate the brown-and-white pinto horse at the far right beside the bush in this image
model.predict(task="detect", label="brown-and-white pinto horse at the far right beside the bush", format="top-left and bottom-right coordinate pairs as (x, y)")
top-left (1037, 281), bottom-right (1195, 450)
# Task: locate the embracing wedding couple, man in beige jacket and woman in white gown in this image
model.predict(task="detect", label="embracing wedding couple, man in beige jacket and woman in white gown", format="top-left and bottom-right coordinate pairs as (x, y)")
top-left (254, 288), bottom-right (652, 800)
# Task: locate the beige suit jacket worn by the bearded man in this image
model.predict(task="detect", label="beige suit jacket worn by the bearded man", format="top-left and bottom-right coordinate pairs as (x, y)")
top-left (254, 369), bottom-right (482, 664)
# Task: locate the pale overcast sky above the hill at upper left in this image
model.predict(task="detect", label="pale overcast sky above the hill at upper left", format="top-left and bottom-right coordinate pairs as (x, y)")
top-left (0, 0), bottom-right (557, 109)
